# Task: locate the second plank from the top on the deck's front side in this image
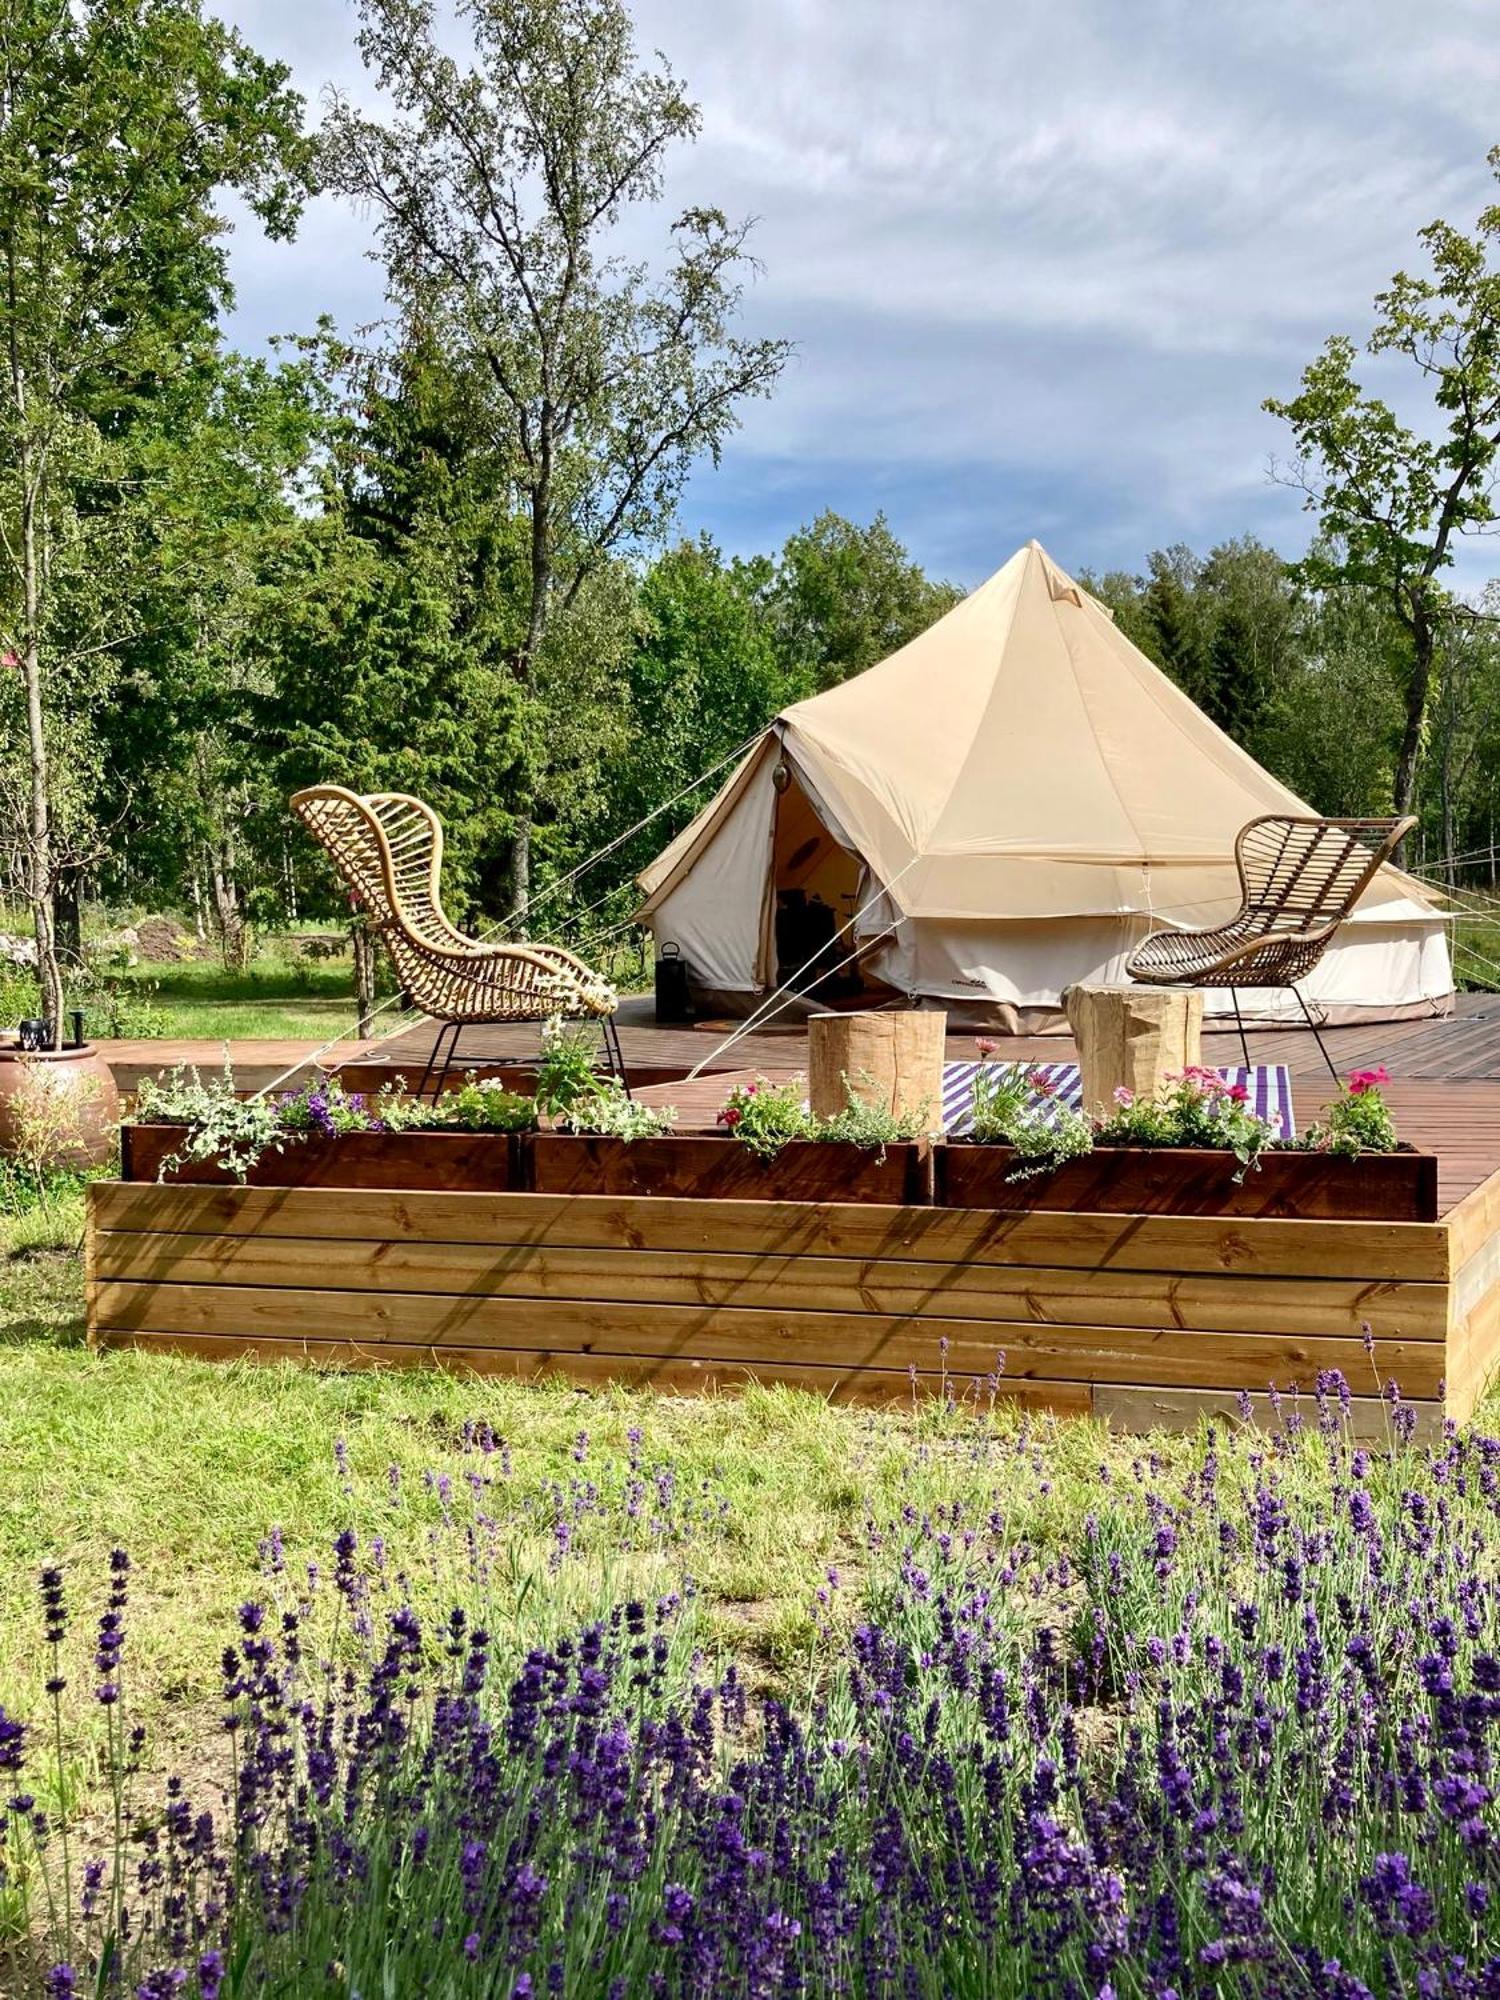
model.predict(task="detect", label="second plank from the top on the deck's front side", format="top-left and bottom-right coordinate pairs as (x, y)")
top-left (94, 1230), bottom-right (1448, 1340)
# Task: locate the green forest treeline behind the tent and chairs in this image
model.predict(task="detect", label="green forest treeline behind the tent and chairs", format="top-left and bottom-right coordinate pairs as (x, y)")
top-left (0, 0), bottom-right (1500, 1018)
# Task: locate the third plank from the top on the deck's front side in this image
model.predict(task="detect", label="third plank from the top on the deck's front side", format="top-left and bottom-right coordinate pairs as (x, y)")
top-left (94, 1280), bottom-right (1448, 1396)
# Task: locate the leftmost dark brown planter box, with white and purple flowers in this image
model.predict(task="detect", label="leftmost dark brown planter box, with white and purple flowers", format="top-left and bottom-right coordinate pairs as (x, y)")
top-left (120, 1124), bottom-right (524, 1194)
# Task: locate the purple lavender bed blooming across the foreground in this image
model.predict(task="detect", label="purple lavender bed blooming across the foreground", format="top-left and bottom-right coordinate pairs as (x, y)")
top-left (11, 1376), bottom-right (1500, 2000)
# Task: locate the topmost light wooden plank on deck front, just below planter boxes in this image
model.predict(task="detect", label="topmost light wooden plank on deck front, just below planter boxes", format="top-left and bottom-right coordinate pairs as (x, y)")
top-left (90, 1182), bottom-right (1448, 1280)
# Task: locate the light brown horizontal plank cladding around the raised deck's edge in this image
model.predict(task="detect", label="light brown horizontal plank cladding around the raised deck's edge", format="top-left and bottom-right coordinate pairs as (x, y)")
top-left (88, 1176), bottom-right (1500, 1438)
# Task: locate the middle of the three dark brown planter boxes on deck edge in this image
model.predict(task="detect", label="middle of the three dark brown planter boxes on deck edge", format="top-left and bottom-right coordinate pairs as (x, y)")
top-left (522, 1132), bottom-right (932, 1204)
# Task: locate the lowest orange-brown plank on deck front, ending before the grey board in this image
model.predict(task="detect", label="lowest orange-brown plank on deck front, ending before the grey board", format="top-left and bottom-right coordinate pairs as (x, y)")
top-left (85, 1328), bottom-right (1090, 1416)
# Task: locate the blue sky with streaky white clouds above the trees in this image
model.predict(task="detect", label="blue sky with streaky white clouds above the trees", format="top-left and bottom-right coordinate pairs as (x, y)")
top-left (220, 0), bottom-right (1500, 590)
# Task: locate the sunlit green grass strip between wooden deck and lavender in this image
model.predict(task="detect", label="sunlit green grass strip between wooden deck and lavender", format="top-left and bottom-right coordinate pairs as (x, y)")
top-left (0, 1196), bottom-right (1500, 1840)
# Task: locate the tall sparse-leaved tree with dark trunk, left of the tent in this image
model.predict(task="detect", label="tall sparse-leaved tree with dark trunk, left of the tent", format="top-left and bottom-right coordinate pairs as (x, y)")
top-left (326, 0), bottom-right (786, 908)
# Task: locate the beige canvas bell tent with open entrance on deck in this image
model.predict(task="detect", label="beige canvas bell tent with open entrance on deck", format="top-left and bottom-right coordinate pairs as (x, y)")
top-left (640, 542), bottom-right (1452, 1032)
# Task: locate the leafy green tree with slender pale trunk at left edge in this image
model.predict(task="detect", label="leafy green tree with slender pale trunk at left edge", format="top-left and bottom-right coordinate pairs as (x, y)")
top-left (0, 0), bottom-right (310, 1034)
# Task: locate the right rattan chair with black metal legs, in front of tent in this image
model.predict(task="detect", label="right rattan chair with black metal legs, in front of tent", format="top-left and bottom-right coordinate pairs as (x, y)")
top-left (1126, 812), bottom-right (1416, 1078)
